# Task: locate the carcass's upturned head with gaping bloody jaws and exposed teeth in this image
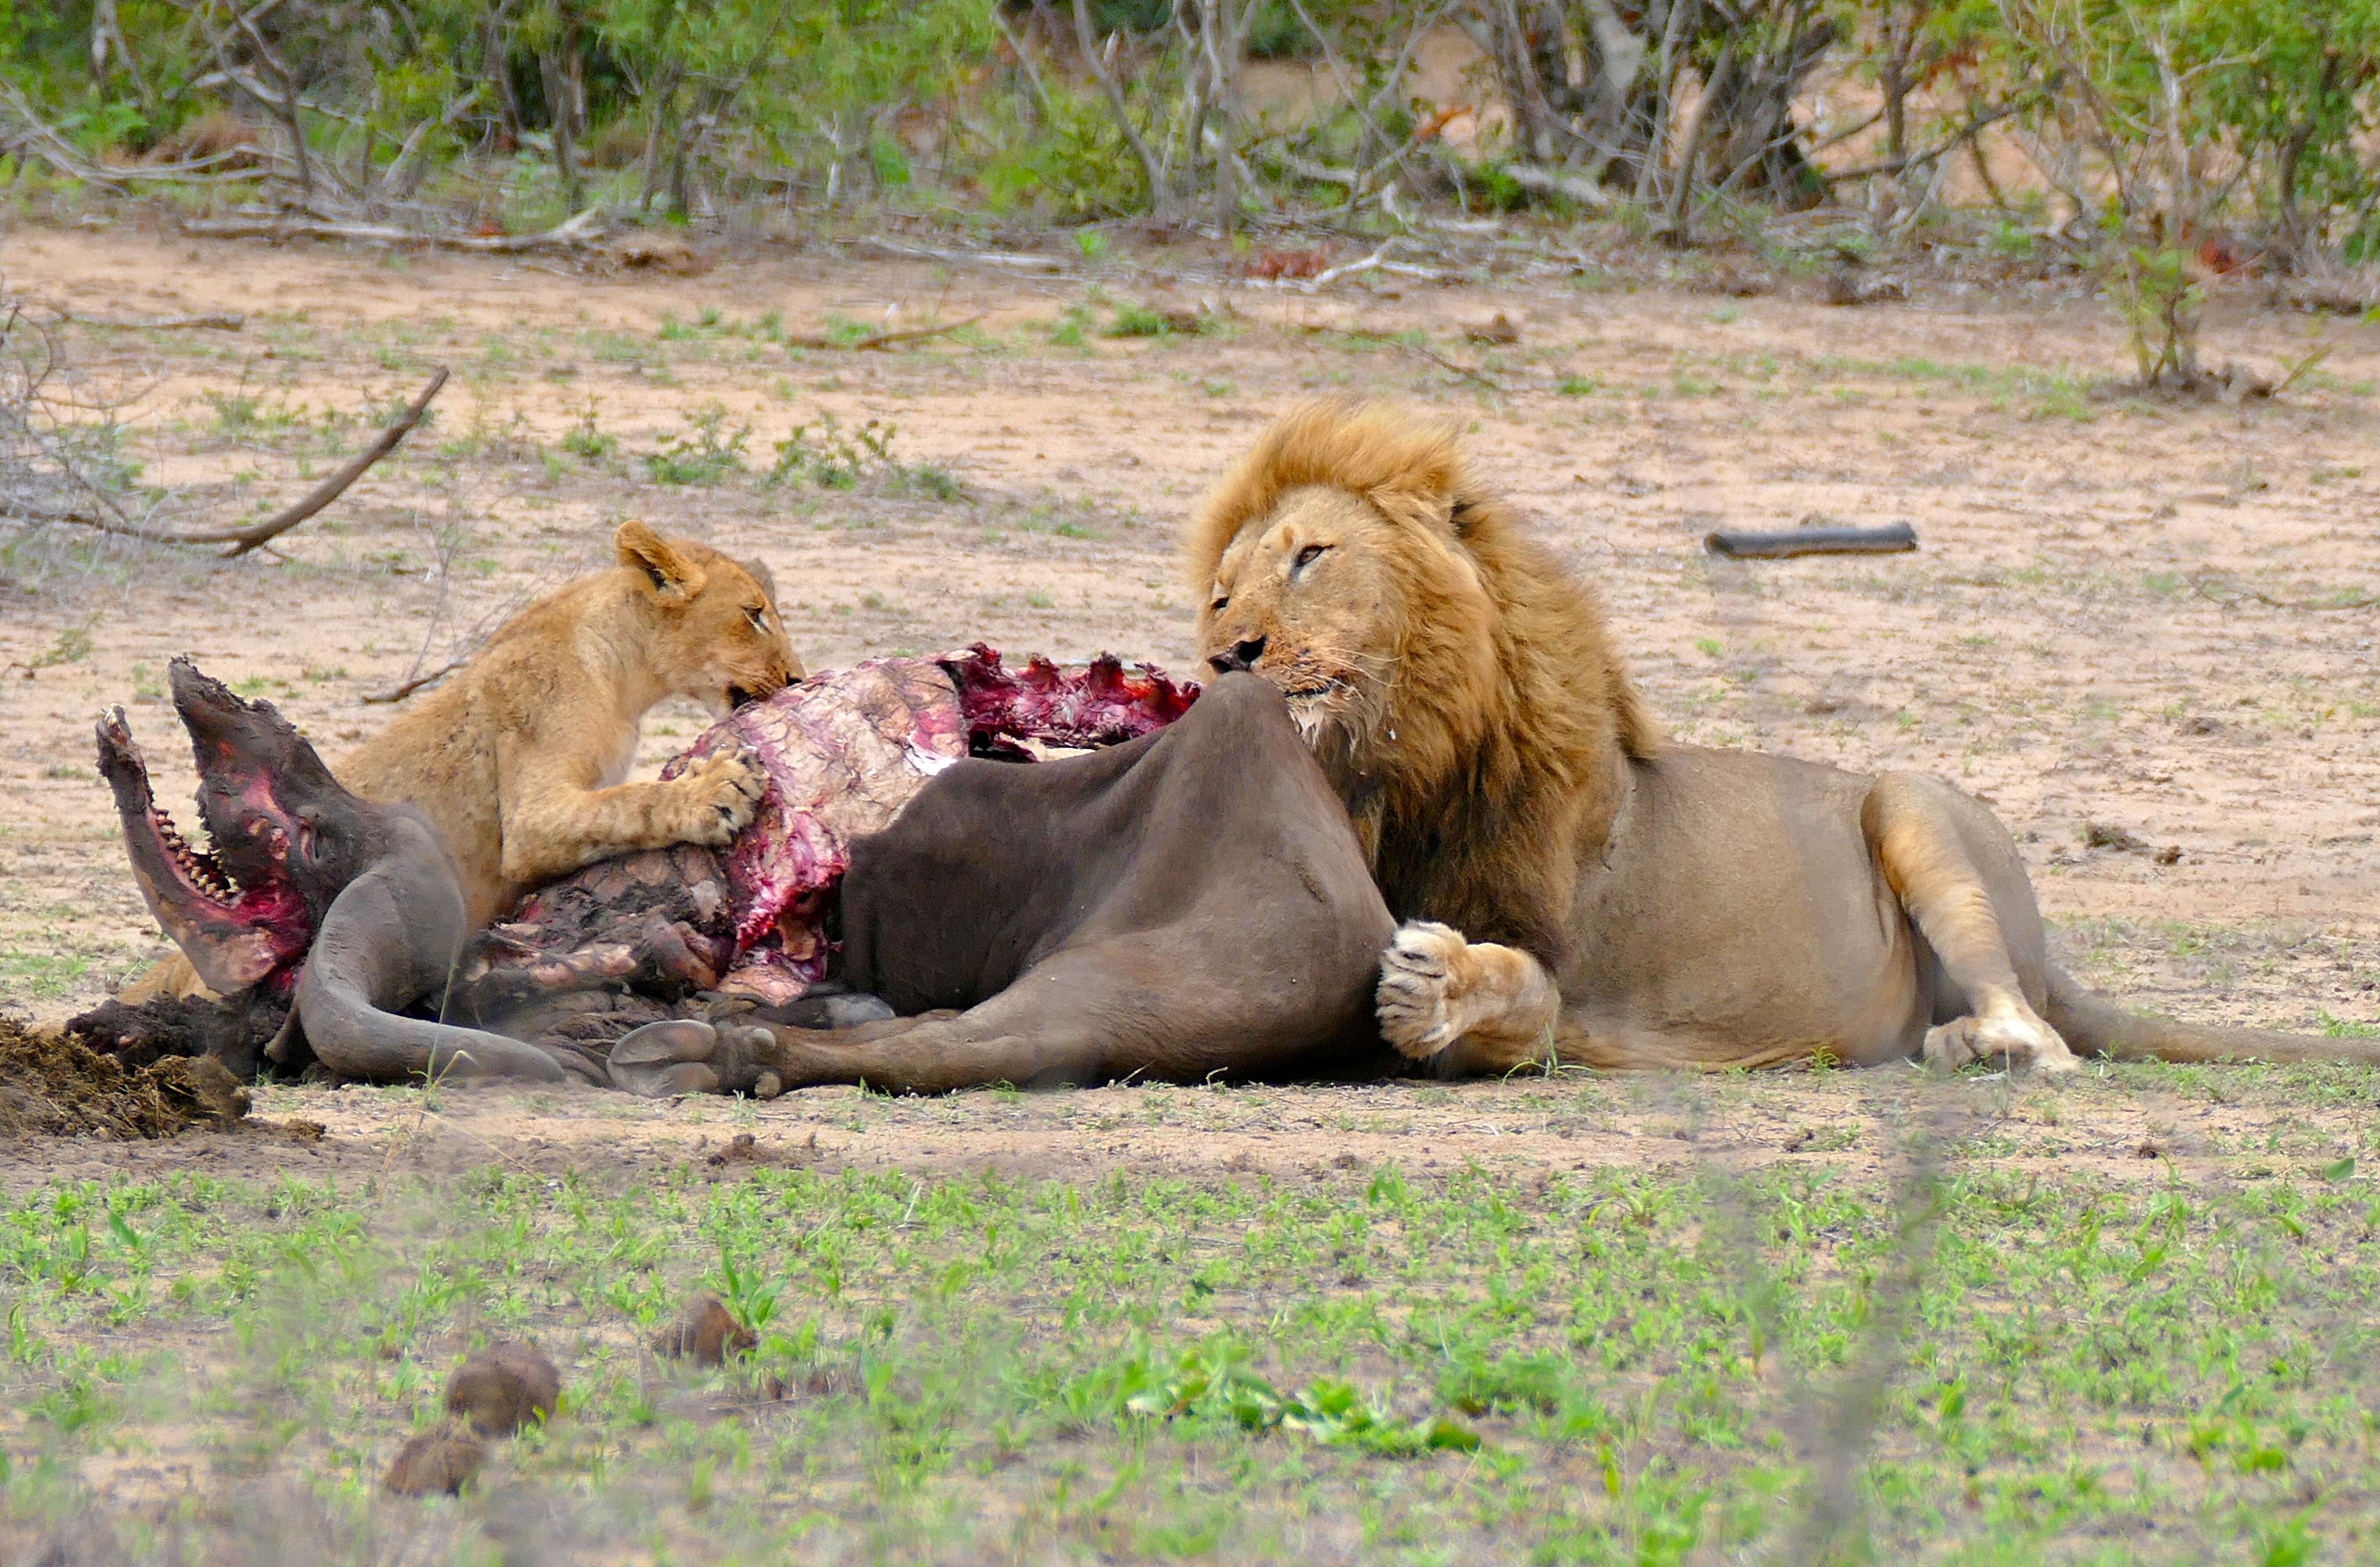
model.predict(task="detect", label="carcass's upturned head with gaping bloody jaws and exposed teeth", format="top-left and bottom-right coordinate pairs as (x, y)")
top-left (97, 660), bottom-right (345, 996)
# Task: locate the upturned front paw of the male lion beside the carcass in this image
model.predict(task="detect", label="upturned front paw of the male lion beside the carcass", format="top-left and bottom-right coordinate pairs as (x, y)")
top-left (1376, 919), bottom-right (1561, 1071)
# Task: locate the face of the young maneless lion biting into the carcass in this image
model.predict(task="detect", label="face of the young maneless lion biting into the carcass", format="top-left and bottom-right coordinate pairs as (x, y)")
top-left (616, 521), bottom-right (802, 717)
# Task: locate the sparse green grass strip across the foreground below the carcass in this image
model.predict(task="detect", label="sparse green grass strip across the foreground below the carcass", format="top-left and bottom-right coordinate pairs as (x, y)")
top-left (0, 1114), bottom-right (2380, 1565)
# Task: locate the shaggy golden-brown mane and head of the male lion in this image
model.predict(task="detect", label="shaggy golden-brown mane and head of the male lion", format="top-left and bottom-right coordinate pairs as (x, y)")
top-left (1185, 398), bottom-right (1661, 952)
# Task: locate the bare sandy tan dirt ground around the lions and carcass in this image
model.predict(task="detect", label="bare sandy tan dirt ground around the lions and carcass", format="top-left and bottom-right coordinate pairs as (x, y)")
top-left (0, 222), bottom-right (2380, 1183)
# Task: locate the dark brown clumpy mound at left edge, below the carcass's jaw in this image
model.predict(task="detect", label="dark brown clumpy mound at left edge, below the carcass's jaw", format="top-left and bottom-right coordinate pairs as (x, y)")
top-left (0, 1017), bottom-right (248, 1141)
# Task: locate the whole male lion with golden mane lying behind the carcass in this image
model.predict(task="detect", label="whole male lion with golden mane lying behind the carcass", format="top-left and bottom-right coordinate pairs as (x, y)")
top-left (1188, 400), bottom-right (2380, 1071)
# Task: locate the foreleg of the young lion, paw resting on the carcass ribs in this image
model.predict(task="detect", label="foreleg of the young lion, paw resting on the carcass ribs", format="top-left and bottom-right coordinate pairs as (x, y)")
top-left (504, 748), bottom-right (769, 884)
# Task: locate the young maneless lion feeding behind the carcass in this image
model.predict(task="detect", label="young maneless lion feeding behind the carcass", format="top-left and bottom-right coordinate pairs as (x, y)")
top-left (122, 521), bottom-right (802, 1003)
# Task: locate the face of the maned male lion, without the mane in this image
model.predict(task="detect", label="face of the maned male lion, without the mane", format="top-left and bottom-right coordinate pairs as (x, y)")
top-left (1197, 486), bottom-right (1409, 748)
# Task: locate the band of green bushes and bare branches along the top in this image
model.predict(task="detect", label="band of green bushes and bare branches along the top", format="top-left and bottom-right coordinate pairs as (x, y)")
top-left (0, 0), bottom-right (2380, 269)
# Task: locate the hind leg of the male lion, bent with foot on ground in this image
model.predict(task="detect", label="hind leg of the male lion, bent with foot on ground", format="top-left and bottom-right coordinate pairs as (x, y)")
top-left (1861, 772), bottom-right (2078, 1071)
